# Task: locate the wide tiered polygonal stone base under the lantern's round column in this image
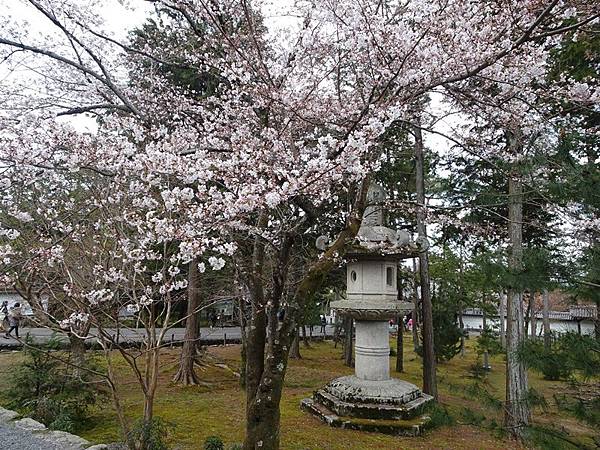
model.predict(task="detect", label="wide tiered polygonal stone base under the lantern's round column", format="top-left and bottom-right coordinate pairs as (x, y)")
top-left (301, 376), bottom-right (433, 436)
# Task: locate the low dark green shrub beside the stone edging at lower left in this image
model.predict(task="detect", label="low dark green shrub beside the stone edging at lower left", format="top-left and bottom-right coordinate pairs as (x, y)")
top-left (3, 337), bottom-right (105, 431)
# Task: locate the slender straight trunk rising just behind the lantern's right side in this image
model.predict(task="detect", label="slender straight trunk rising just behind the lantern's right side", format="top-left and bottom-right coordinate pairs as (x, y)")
top-left (414, 121), bottom-right (437, 400)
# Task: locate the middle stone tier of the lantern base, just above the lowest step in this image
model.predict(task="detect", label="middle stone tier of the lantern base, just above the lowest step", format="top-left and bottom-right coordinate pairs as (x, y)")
top-left (314, 389), bottom-right (432, 420)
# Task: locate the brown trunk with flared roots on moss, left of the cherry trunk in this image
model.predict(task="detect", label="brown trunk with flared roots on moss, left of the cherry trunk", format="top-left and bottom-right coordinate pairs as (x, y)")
top-left (173, 258), bottom-right (201, 385)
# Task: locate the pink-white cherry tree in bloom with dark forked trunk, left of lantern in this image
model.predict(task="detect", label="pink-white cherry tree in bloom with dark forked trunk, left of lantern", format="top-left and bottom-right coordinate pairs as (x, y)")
top-left (0, 0), bottom-right (597, 449)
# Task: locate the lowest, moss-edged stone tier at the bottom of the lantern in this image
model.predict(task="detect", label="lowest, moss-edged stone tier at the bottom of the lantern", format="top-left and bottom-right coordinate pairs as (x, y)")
top-left (300, 398), bottom-right (431, 436)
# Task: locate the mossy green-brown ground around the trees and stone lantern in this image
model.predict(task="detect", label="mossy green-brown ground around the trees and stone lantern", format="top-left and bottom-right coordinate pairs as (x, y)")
top-left (0, 335), bottom-right (598, 450)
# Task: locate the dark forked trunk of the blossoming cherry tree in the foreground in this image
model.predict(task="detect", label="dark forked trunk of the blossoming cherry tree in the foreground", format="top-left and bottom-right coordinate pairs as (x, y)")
top-left (244, 181), bottom-right (369, 450)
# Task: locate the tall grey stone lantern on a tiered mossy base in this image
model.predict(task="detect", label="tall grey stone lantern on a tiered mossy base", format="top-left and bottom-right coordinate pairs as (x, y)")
top-left (302, 186), bottom-right (432, 435)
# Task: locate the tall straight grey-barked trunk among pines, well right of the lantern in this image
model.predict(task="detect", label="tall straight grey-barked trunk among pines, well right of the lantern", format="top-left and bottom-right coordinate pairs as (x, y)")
top-left (505, 153), bottom-right (530, 439)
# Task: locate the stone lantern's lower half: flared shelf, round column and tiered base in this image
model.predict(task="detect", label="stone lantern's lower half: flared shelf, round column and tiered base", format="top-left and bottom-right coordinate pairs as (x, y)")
top-left (301, 300), bottom-right (433, 436)
